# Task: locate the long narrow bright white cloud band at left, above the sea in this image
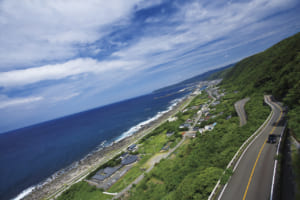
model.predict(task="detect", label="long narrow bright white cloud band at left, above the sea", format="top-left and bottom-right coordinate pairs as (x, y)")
top-left (0, 58), bottom-right (141, 87)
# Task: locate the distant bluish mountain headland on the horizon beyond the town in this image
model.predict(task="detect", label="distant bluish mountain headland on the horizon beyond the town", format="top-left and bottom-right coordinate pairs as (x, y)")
top-left (153, 64), bottom-right (234, 93)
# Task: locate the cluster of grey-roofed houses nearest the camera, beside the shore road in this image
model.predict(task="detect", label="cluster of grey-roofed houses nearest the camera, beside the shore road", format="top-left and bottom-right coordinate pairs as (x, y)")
top-left (92, 144), bottom-right (139, 181)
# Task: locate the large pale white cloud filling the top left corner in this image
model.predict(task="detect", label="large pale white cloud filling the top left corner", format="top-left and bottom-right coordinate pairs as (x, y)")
top-left (0, 0), bottom-right (140, 68)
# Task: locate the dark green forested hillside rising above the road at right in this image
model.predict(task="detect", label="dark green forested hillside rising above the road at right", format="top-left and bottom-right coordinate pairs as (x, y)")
top-left (215, 33), bottom-right (300, 139)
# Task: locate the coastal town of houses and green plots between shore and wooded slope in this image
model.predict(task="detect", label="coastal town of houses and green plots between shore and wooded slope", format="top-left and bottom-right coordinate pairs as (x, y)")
top-left (59, 80), bottom-right (225, 199)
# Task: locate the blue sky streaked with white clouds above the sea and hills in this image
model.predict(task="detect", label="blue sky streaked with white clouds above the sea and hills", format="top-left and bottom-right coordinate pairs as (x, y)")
top-left (0, 0), bottom-right (300, 133)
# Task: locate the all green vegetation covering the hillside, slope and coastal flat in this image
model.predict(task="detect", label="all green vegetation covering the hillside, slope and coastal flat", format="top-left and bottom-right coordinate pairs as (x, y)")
top-left (55, 33), bottom-right (300, 200)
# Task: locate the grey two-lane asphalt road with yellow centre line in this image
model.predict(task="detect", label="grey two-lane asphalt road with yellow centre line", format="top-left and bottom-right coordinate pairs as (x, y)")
top-left (218, 96), bottom-right (284, 200)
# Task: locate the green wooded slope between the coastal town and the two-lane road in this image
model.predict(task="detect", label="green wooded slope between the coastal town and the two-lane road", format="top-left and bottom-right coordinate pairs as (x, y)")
top-left (129, 94), bottom-right (270, 200)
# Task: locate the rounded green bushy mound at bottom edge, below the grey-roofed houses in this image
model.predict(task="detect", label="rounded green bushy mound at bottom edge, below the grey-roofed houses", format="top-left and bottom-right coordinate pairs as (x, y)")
top-left (57, 181), bottom-right (111, 200)
